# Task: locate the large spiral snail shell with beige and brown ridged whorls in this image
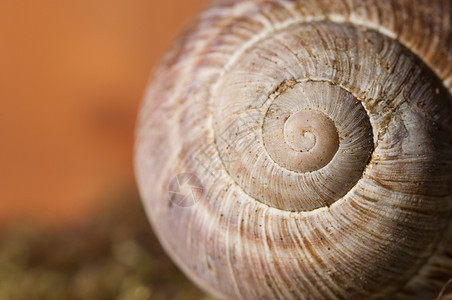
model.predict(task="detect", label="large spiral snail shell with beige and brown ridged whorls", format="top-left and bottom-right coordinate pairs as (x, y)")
top-left (135, 0), bottom-right (452, 299)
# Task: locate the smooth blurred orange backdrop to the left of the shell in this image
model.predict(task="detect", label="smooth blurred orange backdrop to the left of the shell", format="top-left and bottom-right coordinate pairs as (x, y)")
top-left (0, 0), bottom-right (208, 225)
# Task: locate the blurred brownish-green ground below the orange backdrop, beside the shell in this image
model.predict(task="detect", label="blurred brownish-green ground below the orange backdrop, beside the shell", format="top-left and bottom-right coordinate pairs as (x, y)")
top-left (0, 192), bottom-right (211, 300)
